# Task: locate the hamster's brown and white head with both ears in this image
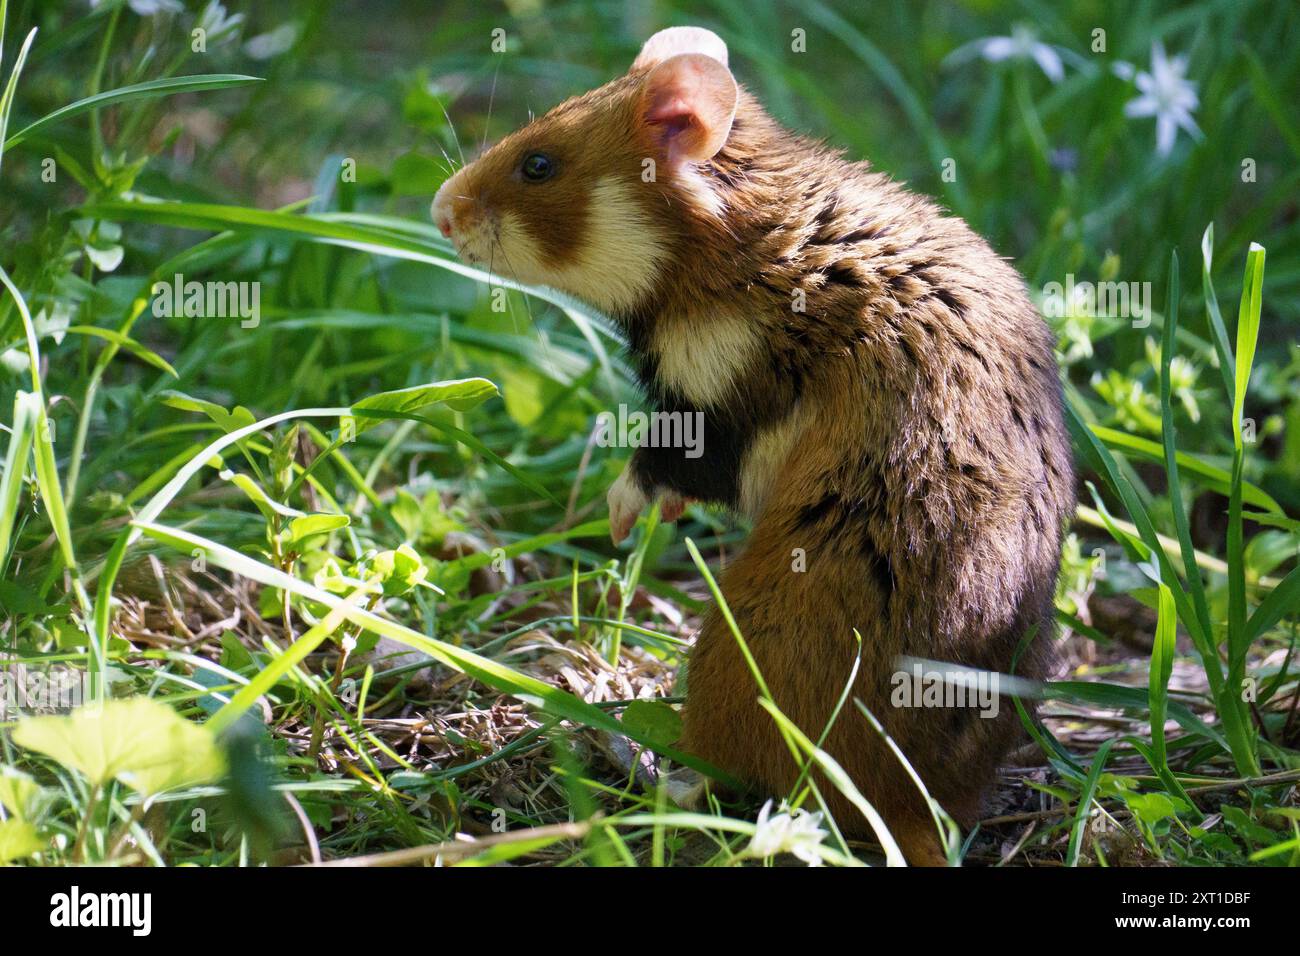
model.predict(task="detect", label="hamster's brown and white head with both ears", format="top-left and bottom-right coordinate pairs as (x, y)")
top-left (433, 27), bottom-right (738, 316)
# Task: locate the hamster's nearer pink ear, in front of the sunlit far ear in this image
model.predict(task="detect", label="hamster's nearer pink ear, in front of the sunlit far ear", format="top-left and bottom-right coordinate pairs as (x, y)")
top-left (641, 52), bottom-right (740, 163)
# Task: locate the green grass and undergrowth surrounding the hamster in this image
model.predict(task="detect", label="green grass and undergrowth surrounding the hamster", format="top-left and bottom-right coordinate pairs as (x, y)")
top-left (0, 0), bottom-right (1300, 865)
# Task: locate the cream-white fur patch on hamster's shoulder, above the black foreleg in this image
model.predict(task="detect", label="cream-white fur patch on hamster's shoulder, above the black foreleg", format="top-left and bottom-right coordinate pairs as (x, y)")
top-left (650, 312), bottom-right (763, 407)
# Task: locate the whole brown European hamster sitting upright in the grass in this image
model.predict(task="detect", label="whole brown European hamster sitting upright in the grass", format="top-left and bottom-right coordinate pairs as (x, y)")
top-left (433, 27), bottom-right (1074, 864)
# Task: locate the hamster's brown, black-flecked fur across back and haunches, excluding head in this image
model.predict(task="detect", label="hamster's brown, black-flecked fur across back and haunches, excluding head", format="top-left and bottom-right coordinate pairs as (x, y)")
top-left (634, 96), bottom-right (1074, 862)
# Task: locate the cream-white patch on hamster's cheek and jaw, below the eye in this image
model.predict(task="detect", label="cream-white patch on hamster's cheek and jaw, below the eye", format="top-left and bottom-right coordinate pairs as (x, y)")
top-left (497, 177), bottom-right (668, 312)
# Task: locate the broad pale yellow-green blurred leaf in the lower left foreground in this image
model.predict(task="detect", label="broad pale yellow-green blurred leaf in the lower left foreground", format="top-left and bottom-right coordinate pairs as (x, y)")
top-left (13, 697), bottom-right (224, 796)
